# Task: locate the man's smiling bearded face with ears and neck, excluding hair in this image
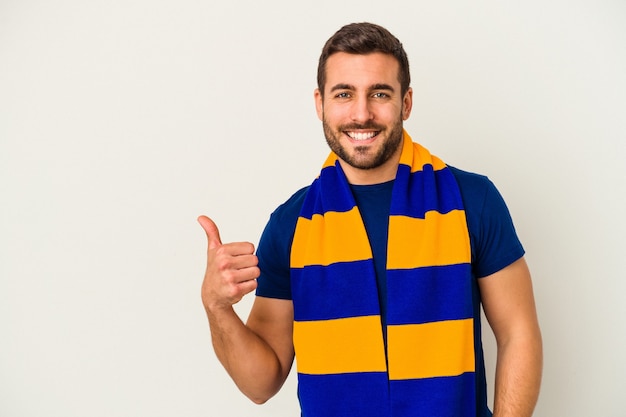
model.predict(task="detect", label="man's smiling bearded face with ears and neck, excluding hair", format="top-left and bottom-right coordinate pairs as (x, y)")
top-left (315, 52), bottom-right (412, 182)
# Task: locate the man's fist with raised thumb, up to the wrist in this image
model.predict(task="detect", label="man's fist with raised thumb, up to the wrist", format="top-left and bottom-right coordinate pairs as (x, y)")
top-left (198, 216), bottom-right (260, 312)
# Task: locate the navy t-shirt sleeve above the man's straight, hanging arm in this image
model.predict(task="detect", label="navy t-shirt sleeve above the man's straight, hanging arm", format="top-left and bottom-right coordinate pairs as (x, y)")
top-left (461, 171), bottom-right (524, 278)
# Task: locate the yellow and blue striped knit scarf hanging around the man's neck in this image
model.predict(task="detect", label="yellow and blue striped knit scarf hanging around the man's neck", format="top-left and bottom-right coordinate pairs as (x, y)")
top-left (291, 132), bottom-right (476, 417)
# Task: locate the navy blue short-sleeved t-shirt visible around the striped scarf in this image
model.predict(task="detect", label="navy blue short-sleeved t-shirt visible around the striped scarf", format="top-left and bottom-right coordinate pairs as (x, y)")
top-left (256, 167), bottom-right (524, 416)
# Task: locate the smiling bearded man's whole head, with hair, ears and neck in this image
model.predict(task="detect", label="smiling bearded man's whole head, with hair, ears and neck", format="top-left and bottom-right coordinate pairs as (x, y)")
top-left (315, 23), bottom-right (412, 184)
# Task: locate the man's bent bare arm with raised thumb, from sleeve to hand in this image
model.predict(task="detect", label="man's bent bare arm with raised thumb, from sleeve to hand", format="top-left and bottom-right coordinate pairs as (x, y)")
top-left (198, 216), bottom-right (294, 404)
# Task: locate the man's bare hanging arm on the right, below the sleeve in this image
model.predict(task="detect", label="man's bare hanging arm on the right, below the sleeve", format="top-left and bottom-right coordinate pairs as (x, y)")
top-left (478, 258), bottom-right (543, 417)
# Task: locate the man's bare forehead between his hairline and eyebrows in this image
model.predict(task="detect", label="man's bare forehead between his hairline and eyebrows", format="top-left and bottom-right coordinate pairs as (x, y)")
top-left (325, 52), bottom-right (400, 91)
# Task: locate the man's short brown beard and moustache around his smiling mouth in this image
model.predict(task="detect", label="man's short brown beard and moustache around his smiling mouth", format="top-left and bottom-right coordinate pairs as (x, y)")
top-left (322, 117), bottom-right (403, 170)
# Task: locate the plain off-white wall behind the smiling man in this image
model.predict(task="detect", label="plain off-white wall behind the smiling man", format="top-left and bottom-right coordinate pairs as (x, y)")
top-left (0, 0), bottom-right (626, 417)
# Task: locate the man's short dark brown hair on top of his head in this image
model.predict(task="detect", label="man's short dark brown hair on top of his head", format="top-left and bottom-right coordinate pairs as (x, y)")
top-left (317, 22), bottom-right (411, 96)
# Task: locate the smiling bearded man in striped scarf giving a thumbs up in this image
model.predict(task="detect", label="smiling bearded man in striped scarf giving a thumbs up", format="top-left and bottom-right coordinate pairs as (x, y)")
top-left (199, 23), bottom-right (542, 417)
